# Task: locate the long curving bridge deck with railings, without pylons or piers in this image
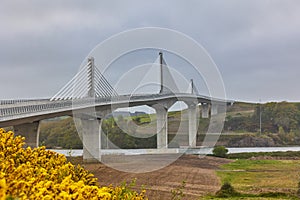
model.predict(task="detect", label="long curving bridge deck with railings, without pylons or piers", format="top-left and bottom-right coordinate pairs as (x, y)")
top-left (0, 93), bottom-right (231, 125)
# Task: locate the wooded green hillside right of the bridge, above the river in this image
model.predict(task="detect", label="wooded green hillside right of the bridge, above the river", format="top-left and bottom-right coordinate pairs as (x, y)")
top-left (224, 102), bottom-right (300, 136)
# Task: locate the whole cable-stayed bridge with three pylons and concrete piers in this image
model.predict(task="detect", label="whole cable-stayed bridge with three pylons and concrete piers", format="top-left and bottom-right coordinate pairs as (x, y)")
top-left (0, 53), bottom-right (232, 160)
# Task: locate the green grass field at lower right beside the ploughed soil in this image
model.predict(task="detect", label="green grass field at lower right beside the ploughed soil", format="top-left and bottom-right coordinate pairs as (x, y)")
top-left (207, 160), bottom-right (300, 199)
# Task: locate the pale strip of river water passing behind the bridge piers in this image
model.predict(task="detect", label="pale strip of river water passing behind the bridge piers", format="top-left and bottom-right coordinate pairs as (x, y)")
top-left (51, 146), bottom-right (300, 156)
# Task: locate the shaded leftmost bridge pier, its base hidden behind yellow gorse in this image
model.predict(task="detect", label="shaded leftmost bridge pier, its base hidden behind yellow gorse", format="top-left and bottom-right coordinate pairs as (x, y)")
top-left (14, 122), bottom-right (40, 148)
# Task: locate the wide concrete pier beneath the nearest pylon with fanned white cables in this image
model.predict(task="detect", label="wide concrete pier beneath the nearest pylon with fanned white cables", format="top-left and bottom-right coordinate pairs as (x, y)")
top-left (81, 119), bottom-right (101, 163)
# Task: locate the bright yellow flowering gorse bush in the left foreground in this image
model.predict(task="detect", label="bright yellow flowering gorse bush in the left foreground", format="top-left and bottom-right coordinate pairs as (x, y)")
top-left (0, 128), bottom-right (147, 200)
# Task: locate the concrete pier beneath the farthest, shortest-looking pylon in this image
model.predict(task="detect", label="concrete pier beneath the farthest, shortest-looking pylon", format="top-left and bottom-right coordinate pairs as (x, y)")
top-left (188, 104), bottom-right (198, 148)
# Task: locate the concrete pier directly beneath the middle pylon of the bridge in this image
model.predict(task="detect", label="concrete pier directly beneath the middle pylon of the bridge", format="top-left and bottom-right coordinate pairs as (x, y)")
top-left (154, 105), bottom-right (168, 149)
